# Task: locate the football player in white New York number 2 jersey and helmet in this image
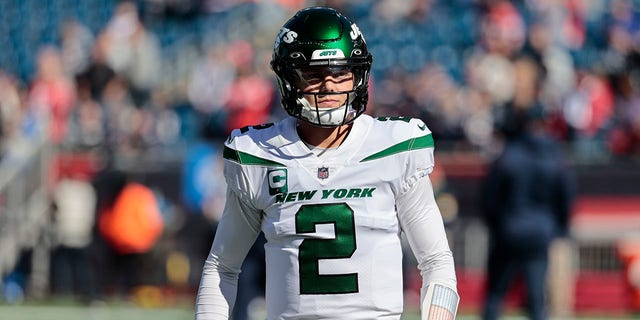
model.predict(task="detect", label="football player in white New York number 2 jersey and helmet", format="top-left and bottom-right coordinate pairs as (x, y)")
top-left (195, 7), bottom-right (459, 320)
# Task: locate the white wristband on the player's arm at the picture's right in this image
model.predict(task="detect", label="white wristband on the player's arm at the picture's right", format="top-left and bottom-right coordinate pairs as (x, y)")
top-left (421, 282), bottom-right (460, 320)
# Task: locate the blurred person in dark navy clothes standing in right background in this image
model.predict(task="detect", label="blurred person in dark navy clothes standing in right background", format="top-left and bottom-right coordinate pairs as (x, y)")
top-left (482, 57), bottom-right (574, 320)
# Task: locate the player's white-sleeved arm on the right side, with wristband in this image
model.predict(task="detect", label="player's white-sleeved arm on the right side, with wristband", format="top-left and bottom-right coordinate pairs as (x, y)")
top-left (396, 174), bottom-right (460, 320)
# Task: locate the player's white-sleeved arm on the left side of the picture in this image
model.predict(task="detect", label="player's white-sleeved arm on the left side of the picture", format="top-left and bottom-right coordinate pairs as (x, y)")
top-left (195, 190), bottom-right (260, 320)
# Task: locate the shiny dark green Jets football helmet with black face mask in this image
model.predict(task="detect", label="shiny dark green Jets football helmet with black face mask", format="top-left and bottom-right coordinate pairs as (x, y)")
top-left (271, 7), bottom-right (372, 127)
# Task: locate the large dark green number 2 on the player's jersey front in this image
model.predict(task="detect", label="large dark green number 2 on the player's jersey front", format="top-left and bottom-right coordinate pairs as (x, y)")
top-left (296, 203), bottom-right (358, 294)
